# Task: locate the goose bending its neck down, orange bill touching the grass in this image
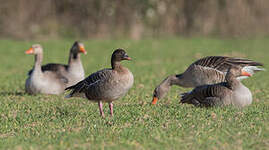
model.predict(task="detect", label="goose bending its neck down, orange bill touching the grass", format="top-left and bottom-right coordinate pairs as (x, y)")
top-left (152, 56), bottom-right (264, 104)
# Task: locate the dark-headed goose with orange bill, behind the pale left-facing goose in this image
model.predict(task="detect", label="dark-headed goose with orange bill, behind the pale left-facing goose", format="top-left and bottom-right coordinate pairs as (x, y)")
top-left (28, 41), bottom-right (87, 87)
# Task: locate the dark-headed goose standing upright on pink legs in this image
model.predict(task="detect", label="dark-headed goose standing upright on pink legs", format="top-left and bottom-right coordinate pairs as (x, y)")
top-left (66, 49), bottom-right (134, 117)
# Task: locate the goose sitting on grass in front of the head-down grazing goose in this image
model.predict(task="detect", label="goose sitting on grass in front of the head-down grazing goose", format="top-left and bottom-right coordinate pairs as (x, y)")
top-left (181, 68), bottom-right (252, 108)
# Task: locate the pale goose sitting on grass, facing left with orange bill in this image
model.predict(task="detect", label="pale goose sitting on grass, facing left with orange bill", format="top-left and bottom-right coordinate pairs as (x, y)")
top-left (25, 44), bottom-right (67, 94)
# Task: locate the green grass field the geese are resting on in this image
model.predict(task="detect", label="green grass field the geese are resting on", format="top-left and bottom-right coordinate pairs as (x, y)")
top-left (0, 38), bottom-right (269, 150)
